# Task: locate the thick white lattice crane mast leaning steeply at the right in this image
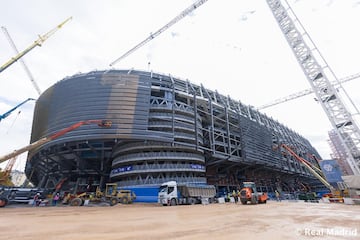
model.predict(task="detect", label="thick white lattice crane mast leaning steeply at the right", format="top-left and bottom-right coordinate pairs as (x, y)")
top-left (267, 0), bottom-right (360, 175)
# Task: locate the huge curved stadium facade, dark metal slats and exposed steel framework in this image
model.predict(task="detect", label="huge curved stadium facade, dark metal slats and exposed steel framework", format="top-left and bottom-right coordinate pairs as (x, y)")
top-left (26, 70), bottom-right (320, 195)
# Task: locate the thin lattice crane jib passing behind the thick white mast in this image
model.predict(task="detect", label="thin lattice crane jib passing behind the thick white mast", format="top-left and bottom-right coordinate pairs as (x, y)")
top-left (257, 73), bottom-right (360, 110)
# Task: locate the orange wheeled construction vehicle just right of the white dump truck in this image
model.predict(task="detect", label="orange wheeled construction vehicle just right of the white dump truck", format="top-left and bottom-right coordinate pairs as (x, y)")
top-left (239, 182), bottom-right (268, 204)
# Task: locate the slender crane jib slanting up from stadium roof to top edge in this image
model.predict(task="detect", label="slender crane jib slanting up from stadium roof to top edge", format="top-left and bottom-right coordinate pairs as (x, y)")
top-left (110, 0), bottom-right (207, 66)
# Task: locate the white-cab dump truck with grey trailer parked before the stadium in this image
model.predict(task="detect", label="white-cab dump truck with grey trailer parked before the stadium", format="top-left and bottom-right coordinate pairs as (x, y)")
top-left (158, 181), bottom-right (216, 206)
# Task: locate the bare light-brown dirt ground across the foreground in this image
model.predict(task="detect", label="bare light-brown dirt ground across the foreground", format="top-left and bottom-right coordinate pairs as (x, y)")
top-left (0, 201), bottom-right (360, 240)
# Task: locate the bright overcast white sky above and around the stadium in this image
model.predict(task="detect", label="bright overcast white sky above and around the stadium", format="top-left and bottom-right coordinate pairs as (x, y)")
top-left (0, 0), bottom-right (360, 169)
